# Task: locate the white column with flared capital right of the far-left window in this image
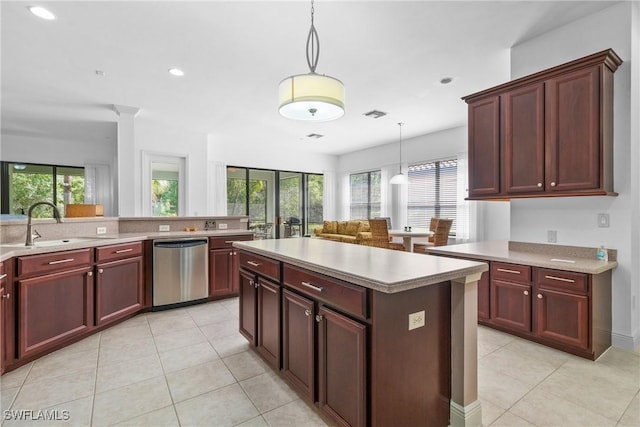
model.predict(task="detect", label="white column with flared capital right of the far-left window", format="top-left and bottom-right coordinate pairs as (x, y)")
top-left (112, 104), bottom-right (140, 216)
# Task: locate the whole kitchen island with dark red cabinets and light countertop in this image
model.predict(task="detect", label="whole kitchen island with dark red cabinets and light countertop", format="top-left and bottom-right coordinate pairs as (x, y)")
top-left (234, 238), bottom-right (488, 426)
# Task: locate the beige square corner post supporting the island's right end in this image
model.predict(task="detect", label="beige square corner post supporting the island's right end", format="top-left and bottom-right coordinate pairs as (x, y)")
top-left (450, 273), bottom-right (482, 427)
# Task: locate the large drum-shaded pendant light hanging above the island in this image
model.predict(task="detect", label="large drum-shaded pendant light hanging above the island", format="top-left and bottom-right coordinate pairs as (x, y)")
top-left (278, 0), bottom-right (344, 121)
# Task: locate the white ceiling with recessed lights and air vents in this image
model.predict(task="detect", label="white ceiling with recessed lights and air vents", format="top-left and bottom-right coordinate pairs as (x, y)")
top-left (0, 0), bottom-right (613, 154)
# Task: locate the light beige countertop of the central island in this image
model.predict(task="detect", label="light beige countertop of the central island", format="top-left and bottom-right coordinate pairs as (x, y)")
top-left (233, 238), bottom-right (488, 293)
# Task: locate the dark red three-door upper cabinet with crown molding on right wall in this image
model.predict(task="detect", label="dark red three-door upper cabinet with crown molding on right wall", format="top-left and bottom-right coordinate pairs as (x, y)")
top-left (462, 49), bottom-right (622, 200)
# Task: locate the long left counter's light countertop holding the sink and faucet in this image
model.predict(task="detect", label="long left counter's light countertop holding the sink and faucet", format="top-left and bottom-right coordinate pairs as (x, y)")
top-left (0, 229), bottom-right (253, 262)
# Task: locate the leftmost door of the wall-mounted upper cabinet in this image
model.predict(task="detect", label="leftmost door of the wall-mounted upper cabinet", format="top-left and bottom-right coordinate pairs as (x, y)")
top-left (469, 96), bottom-right (500, 197)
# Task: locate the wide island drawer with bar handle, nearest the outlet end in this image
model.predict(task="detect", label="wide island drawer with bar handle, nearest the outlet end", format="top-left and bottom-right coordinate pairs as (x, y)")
top-left (283, 265), bottom-right (367, 319)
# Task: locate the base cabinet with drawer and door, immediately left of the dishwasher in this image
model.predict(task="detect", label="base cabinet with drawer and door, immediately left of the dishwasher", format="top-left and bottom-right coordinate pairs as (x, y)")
top-left (95, 242), bottom-right (144, 326)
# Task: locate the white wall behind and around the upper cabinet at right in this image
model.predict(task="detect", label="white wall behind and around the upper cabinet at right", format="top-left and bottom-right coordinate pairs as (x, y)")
top-left (511, 2), bottom-right (640, 349)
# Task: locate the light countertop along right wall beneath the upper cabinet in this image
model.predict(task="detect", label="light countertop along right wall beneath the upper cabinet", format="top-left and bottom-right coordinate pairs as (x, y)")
top-left (428, 241), bottom-right (618, 274)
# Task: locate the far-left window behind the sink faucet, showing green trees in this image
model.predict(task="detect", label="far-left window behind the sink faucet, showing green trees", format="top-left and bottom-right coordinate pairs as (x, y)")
top-left (1, 162), bottom-right (85, 218)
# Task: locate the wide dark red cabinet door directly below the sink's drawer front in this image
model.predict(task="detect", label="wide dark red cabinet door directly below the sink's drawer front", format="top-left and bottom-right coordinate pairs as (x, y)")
top-left (18, 267), bottom-right (93, 357)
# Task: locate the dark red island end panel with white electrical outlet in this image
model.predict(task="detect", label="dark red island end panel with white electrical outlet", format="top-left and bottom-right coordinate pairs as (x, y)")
top-left (370, 282), bottom-right (452, 427)
